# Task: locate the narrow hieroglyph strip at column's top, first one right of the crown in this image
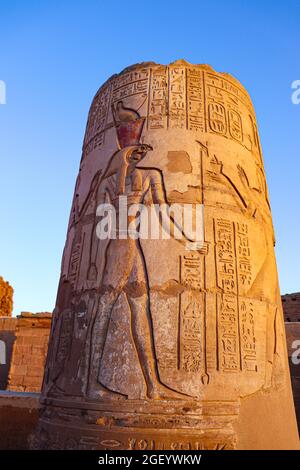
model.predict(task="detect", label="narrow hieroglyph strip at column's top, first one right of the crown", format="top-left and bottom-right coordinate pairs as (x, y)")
top-left (148, 67), bottom-right (168, 129)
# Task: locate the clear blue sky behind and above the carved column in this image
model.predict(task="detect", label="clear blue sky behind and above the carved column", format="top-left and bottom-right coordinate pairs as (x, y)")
top-left (0, 0), bottom-right (300, 314)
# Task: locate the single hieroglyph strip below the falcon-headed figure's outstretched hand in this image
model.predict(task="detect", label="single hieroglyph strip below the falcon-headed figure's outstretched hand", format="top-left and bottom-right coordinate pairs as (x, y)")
top-left (179, 252), bottom-right (203, 372)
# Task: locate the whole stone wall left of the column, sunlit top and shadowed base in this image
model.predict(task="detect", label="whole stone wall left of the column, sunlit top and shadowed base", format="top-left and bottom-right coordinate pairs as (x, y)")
top-left (0, 312), bottom-right (51, 450)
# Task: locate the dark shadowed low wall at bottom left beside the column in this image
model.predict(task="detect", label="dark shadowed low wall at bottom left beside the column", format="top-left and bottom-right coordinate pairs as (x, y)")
top-left (0, 391), bottom-right (39, 450)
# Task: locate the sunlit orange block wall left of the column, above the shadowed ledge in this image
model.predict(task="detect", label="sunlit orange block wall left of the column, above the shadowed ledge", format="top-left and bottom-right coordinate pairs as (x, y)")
top-left (7, 312), bottom-right (52, 392)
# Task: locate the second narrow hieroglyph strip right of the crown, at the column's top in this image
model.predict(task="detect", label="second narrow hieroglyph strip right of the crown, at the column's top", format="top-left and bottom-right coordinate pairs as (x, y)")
top-left (169, 67), bottom-right (186, 129)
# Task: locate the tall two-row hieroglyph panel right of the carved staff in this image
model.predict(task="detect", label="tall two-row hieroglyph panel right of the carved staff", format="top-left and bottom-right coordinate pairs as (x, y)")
top-left (215, 219), bottom-right (257, 371)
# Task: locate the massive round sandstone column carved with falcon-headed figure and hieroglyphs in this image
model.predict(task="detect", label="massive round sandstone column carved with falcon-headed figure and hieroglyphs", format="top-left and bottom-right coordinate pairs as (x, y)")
top-left (34, 61), bottom-right (299, 449)
